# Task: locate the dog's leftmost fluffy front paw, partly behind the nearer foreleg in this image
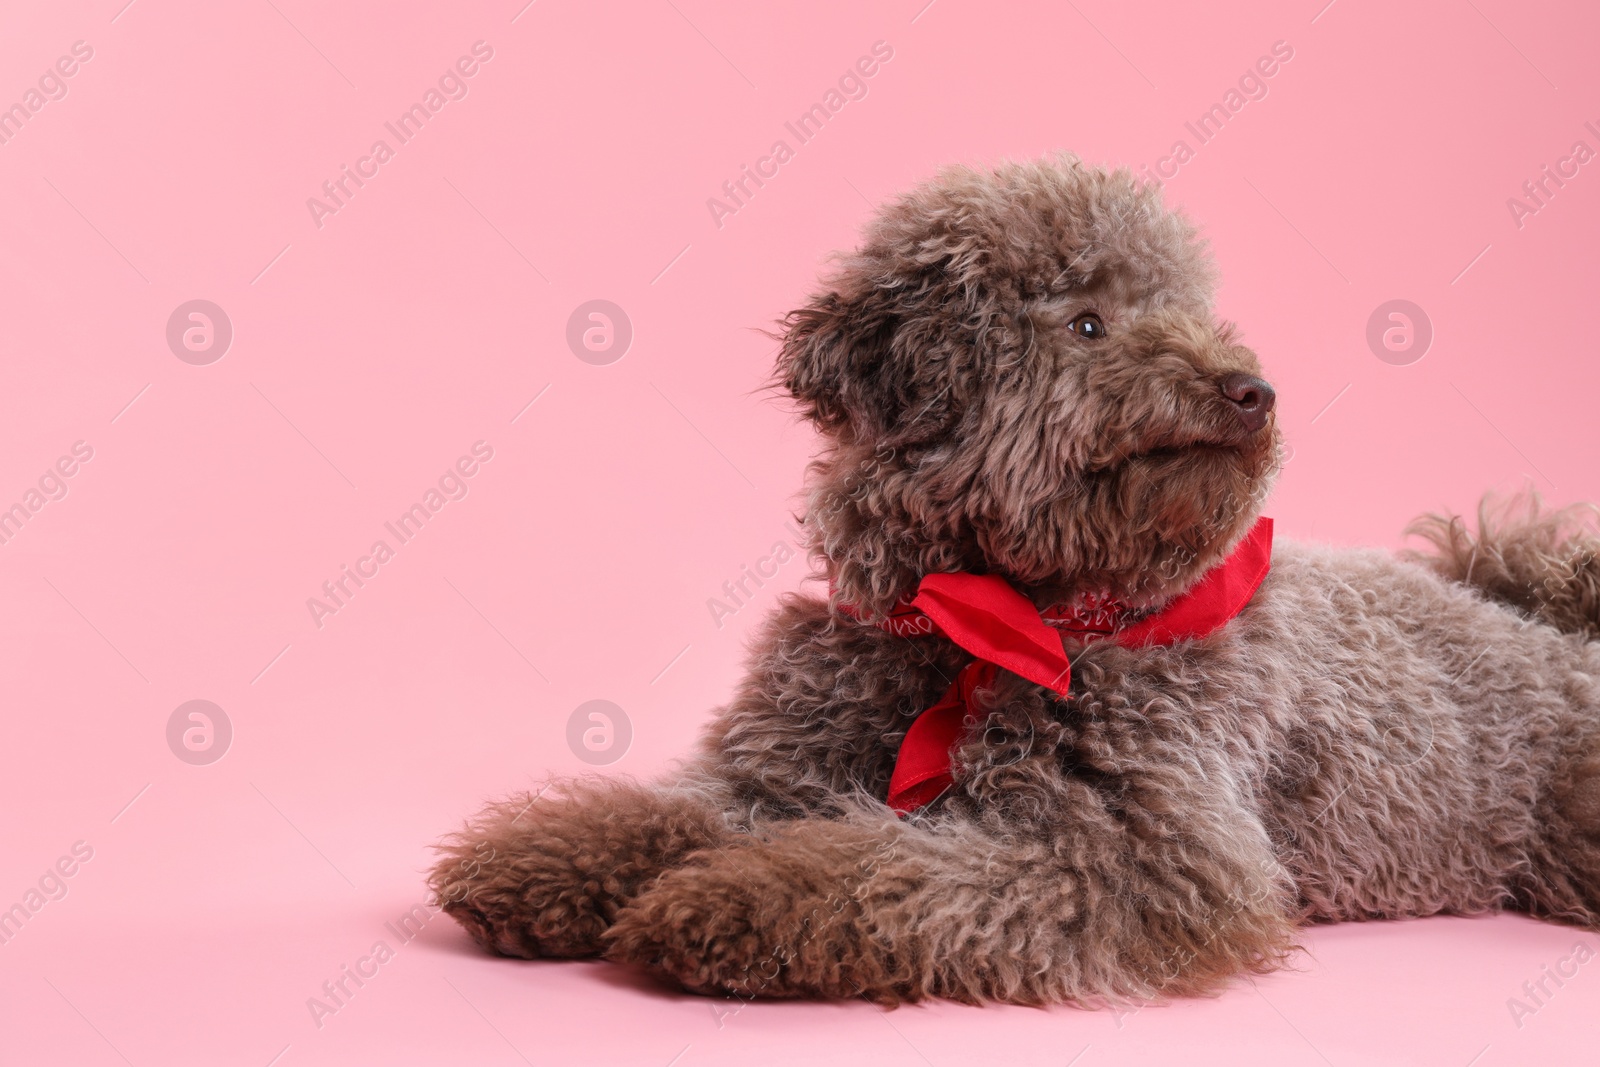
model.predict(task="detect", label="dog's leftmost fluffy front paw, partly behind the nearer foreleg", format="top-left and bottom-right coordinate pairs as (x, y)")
top-left (429, 777), bottom-right (730, 958)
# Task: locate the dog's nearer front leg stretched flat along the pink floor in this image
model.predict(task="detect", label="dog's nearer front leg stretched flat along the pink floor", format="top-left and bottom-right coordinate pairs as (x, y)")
top-left (603, 808), bottom-right (1294, 1005)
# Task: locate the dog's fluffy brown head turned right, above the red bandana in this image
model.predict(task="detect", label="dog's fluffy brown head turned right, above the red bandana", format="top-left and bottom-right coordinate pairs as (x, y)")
top-left (778, 157), bottom-right (1280, 616)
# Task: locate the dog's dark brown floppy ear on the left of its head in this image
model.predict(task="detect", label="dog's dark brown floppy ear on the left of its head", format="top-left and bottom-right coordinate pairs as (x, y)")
top-left (776, 290), bottom-right (954, 446)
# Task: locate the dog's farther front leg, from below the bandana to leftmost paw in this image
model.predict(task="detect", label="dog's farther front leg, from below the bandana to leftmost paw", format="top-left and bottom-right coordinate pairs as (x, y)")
top-left (429, 598), bottom-right (955, 957)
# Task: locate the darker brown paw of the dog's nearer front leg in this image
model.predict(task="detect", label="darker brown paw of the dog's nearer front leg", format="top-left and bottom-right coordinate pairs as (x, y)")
top-left (603, 843), bottom-right (907, 1005)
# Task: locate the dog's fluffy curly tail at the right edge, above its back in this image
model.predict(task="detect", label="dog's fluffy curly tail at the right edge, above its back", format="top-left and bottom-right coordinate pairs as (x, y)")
top-left (1408, 494), bottom-right (1600, 638)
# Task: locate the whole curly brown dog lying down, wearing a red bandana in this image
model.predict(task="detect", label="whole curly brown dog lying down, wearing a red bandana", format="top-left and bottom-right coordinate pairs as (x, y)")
top-left (430, 157), bottom-right (1600, 1005)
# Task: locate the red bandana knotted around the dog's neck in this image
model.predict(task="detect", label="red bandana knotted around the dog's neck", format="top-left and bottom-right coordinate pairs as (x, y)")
top-left (846, 518), bottom-right (1272, 814)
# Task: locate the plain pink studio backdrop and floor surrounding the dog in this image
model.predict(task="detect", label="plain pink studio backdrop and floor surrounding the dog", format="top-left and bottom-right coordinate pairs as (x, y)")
top-left (0, 0), bottom-right (1600, 1067)
